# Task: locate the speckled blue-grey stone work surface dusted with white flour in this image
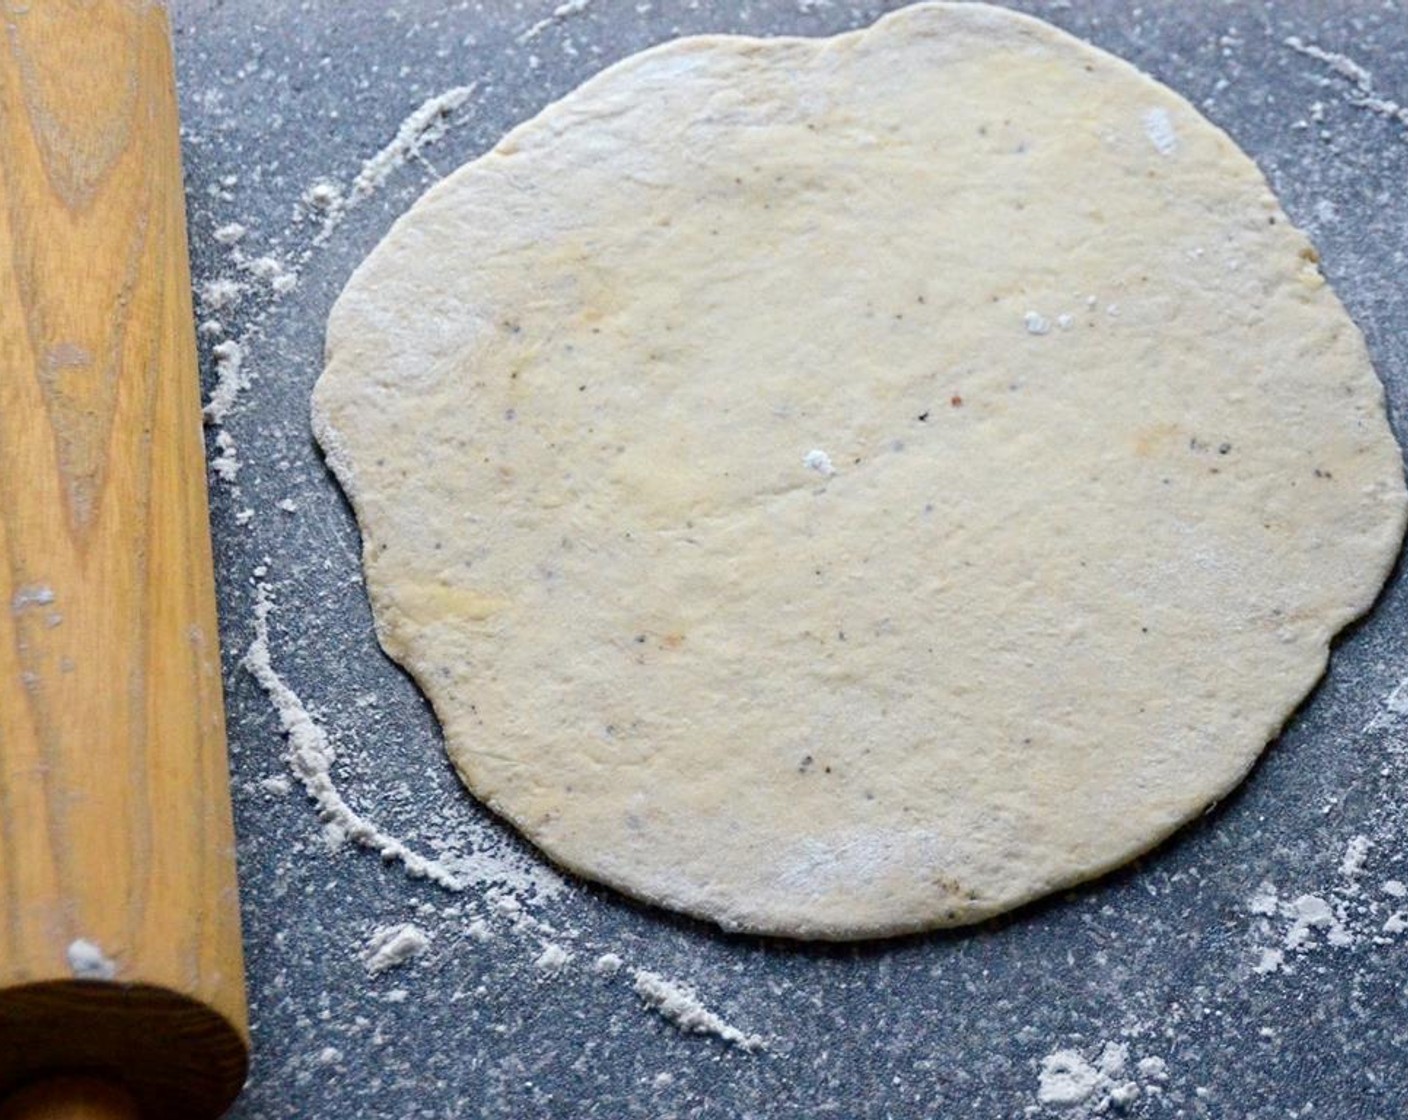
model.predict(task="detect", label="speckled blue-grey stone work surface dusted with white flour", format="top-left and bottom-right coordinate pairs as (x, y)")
top-left (173, 0), bottom-right (1408, 1120)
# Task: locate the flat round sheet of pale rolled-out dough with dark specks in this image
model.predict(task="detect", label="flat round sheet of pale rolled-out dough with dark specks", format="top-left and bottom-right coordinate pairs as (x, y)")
top-left (314, 4), bottom-right (1405, 938)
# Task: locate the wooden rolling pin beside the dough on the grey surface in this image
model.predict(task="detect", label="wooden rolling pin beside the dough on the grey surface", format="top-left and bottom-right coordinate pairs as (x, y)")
top-left (0, 0), bottom-right (248, 1120)
